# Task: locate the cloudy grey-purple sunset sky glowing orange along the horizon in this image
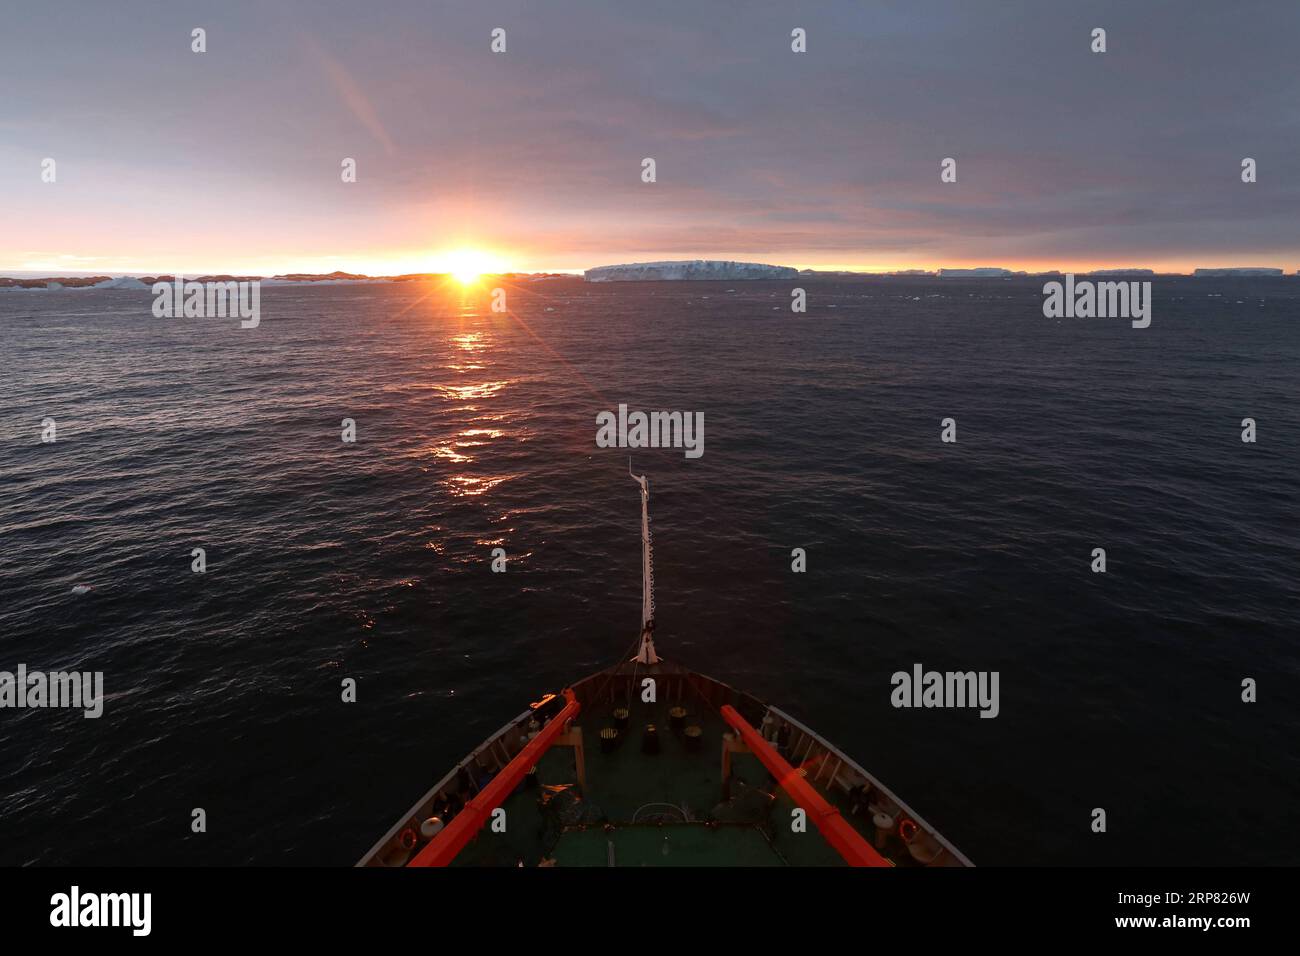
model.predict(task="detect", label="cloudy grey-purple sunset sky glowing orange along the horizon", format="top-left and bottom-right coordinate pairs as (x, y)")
top-left (0, 0), bottom-right (1300, 274)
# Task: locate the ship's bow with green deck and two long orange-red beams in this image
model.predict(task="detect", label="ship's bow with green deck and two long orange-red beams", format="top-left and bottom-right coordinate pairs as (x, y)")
top-left (359, 662), bottom-right (971, 866)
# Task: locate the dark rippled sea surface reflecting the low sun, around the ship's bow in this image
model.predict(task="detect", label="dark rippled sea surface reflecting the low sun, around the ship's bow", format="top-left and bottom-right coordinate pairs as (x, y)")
top-left (0, 278), bottom-right (1300, 865)
